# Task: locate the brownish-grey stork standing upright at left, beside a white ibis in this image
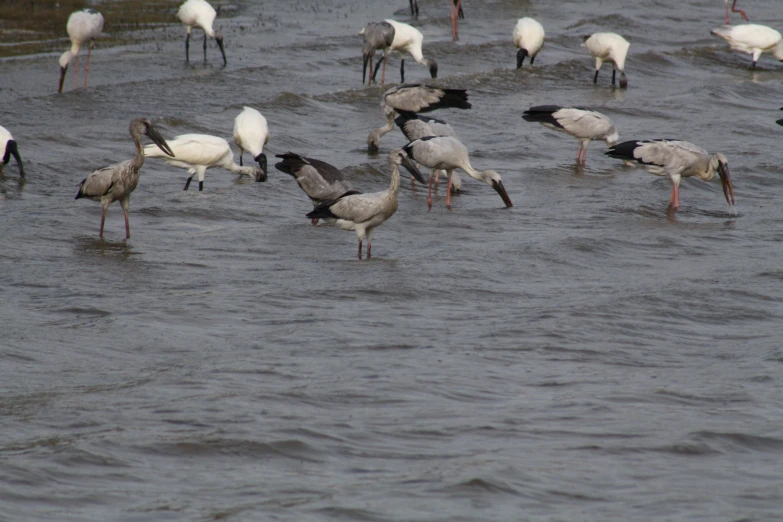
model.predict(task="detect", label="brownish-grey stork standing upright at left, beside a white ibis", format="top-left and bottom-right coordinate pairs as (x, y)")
top-left (74, 118), bottom-right (173, 239)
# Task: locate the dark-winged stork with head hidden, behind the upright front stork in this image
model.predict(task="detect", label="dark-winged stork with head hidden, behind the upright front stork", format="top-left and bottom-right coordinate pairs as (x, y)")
top-left (275, 152), bottom-right (361, 225)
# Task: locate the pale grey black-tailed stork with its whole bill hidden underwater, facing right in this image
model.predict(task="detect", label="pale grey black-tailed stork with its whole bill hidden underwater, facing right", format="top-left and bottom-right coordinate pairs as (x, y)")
top-left (522, 105), bottom-right (620, 165)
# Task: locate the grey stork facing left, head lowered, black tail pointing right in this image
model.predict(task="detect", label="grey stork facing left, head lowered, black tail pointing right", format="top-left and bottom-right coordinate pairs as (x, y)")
top-left (367, 84), bottom-right (471, 151)
